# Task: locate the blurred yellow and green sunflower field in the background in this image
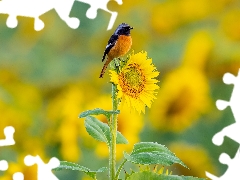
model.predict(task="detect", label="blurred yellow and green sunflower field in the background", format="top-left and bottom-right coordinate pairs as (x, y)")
top-left (0, 0), bottom-right (240, 180)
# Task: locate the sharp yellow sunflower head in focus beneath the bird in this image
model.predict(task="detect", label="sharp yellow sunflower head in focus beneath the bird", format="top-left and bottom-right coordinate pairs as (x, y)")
top-left (110, 52), bottom-right (159, 113)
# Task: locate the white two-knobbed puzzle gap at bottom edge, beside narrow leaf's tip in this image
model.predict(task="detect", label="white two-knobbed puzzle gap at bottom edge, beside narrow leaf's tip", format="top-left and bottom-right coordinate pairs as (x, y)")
top-left (24, 155), bottom-right (60, 180)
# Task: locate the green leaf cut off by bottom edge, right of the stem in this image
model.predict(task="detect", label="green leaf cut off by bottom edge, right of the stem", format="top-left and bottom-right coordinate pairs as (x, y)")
top-left (126, 171), bottom-right (205, 180)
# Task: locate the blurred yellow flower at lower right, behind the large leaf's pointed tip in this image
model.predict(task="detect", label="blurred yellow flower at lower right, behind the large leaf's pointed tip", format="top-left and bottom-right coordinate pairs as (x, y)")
top-left (169, 142), bottom-right (216, 178)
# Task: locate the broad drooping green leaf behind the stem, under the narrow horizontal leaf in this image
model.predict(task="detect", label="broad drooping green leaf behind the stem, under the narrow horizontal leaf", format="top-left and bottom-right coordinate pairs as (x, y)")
top-left (85, 116), bottom-right (128, 145)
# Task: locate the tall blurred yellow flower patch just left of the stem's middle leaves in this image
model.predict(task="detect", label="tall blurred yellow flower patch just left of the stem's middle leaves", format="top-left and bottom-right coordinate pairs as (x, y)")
top-left (48, 84), bottom-right (83, 162)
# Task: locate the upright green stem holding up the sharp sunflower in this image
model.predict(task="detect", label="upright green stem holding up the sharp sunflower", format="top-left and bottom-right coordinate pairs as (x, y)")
top-left (109, 84), bottom-right (118, 180)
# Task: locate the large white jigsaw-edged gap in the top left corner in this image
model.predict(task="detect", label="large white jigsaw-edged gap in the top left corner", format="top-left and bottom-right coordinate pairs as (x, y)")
top-left (0, 0), bottom-right (80, 31)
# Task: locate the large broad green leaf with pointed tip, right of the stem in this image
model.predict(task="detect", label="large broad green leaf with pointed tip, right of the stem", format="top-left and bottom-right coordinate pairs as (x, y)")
top-left (124, 142), bottom-right (187, 168)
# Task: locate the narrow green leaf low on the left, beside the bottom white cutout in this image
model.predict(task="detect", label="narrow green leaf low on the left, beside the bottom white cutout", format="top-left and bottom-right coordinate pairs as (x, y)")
top-left (53, 161), bottom-right (108, 179)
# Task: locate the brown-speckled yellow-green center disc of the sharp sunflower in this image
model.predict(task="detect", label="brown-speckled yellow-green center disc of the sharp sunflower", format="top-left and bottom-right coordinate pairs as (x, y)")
top-left (119, 63), bottom-right (146, 99)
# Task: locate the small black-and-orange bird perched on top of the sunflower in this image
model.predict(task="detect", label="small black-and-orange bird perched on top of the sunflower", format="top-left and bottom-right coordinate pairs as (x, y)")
top-left (100, 23), bottom-right (133, 78)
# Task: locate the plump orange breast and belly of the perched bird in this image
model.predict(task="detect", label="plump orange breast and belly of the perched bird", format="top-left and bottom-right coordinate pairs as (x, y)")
top-left (108, 35), bottom-right (132, 59)
